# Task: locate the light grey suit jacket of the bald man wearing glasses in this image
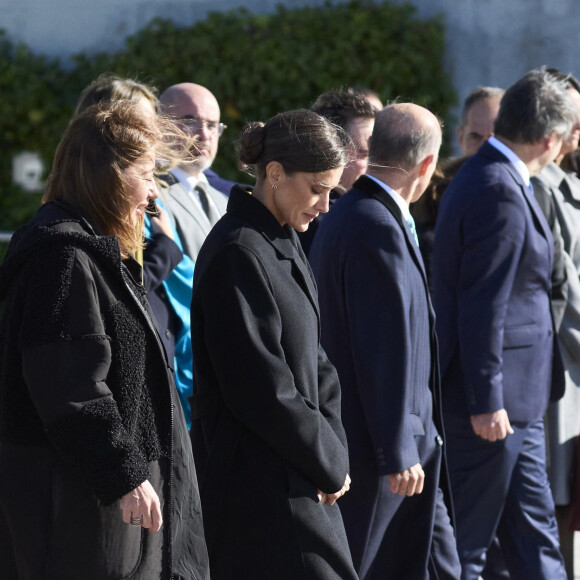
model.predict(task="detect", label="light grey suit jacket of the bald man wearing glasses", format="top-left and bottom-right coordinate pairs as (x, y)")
top-left (166, 183), bottom-right (228, 262)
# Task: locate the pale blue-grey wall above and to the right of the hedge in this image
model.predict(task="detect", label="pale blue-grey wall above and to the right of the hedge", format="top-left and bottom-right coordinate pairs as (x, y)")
top-left (0, 0), bottom-right (580, 145)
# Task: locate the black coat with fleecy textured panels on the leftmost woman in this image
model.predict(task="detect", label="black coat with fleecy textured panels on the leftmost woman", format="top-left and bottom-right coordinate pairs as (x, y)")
top-left (0, 202), bottom-right (209, 580)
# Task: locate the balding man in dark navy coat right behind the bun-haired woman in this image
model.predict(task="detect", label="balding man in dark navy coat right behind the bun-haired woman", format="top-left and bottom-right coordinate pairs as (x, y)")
top-left (310, 103), bottom-right (460, 580)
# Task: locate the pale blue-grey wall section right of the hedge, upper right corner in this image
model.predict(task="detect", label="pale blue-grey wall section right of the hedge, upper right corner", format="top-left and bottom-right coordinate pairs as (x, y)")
top-left (402, 0), bottom-right (580, 112)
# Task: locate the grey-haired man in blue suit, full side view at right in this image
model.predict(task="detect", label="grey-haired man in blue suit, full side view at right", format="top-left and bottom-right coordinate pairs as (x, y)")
top-left (433, 70), bottom-right (575, 580)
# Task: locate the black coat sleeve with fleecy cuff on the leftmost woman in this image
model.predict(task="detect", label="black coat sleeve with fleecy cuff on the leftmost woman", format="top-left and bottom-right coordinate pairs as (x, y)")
top-left (21, 250), bottom-right (149, 503)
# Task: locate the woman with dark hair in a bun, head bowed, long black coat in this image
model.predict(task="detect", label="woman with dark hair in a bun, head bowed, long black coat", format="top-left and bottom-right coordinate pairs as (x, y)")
top-left (192, 110), bottom-right (357, 580)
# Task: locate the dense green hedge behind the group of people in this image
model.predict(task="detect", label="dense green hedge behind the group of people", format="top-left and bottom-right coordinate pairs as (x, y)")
top-left (0, 1), bottom-right (455, 236)
